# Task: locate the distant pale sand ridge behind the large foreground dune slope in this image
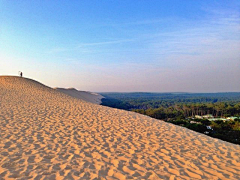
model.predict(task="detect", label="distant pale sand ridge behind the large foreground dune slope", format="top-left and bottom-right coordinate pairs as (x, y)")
top-left (55, 88), bottom-right (104, 104)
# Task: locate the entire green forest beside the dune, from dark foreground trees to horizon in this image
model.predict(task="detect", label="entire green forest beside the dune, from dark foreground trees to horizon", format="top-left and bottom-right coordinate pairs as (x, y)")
top-left (101, 92), bottom-right (240, 144)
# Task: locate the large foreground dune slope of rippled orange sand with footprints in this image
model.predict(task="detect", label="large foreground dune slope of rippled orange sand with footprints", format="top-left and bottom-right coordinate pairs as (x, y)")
top-left (0, 76), bottom-right (240, 180)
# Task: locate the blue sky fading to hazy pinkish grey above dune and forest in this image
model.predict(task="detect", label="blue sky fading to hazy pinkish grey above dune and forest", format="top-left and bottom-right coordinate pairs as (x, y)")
top-left (0, 0), bottom-right (240, 92)
